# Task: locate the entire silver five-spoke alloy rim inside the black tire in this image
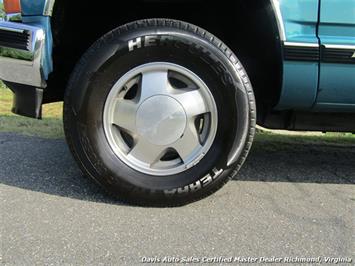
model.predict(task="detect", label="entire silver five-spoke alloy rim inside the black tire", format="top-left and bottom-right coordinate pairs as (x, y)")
top-left (103, 62), bottom-right (218, 176)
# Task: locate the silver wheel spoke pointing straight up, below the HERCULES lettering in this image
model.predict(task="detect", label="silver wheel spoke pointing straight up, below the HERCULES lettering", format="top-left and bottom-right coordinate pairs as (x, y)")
top-left (140, 70), bottom-right (169, 102)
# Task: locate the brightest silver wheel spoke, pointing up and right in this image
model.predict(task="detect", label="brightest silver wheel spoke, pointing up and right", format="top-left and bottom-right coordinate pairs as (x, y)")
top-left (174, 90), bottom-right (209, 117)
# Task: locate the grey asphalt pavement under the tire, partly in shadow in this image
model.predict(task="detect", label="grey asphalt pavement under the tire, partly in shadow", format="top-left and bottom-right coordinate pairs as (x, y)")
top-left (0, 133), bottom-right (355, 265)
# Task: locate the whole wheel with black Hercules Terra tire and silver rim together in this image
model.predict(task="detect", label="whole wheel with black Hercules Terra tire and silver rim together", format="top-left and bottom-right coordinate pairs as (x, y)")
top-left (64, 19), bottom-right (256, 206)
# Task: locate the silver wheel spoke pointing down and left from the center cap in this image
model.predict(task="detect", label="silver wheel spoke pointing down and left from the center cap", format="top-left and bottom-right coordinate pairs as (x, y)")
top-left (127, 138), bottom-right (166, 166)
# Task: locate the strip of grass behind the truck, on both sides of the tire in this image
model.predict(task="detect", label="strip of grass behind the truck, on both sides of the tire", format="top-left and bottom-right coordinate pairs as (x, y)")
top-left (0, 81), bottom-right (355, 144)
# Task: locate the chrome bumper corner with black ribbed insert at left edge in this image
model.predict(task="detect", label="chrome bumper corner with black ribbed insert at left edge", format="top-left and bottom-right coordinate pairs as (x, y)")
top-left (0, 22), bottom-right (46, 88)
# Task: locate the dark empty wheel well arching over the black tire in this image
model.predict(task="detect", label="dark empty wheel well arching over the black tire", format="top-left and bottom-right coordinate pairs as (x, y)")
top-left (45, 0), bottom-right (282, 113)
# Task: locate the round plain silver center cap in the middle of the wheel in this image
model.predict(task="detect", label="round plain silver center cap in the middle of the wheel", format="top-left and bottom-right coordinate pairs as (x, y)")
top-left (136, 95), bottom-right (186, 145)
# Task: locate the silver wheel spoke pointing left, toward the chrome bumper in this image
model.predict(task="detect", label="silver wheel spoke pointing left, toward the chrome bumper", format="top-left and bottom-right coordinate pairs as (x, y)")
top-left (113, 99), bottom-right (138, 133)
